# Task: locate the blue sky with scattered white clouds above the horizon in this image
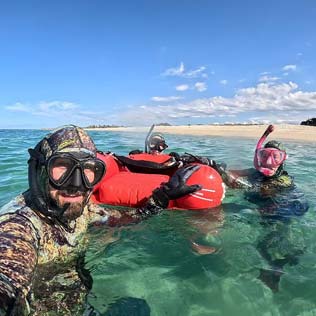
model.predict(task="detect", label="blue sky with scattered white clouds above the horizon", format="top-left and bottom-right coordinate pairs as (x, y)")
top-left (0, 0), bottom-right (316, 128)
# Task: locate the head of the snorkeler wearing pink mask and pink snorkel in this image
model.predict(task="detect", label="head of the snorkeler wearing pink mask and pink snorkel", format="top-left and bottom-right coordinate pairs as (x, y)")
top-left (254, 125), bottom-right (287, 177)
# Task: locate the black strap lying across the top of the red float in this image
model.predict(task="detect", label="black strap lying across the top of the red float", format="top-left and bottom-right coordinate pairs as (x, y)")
top-left (114, 155), bottom-right (179, 174)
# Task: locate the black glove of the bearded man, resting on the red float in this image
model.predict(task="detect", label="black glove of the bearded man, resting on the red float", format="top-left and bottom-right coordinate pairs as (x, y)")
top-left (152, 165), bottom-right (202, 208)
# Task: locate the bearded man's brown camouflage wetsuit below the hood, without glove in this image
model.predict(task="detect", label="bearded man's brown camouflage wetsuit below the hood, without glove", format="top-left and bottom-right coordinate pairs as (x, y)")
top-left (0, 195), bottom-right (160, 316)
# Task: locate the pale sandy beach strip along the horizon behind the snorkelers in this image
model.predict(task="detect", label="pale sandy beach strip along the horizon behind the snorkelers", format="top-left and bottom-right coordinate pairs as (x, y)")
top-left (87, 124), bottom-right (316, 142)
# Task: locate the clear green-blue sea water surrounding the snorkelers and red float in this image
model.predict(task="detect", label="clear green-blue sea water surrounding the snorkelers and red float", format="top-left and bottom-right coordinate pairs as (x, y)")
top-left (0, 130), bottom-right (316, 316)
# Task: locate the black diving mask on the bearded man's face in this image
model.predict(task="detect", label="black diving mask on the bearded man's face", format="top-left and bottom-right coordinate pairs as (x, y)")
top-left (46, 153), bottom-right (106, 189)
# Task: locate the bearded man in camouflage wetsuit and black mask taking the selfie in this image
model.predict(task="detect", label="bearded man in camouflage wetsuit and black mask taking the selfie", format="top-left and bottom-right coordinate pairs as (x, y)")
top-left (0, 125), bottom-right (200, 316)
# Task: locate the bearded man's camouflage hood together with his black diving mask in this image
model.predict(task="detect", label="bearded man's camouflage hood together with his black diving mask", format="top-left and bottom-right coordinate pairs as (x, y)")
top-left (27, 125), bottom-right (105, 220)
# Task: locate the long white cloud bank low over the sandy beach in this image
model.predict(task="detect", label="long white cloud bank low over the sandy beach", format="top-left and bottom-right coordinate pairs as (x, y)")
top-left (117, 82), bottom-right (316, 124)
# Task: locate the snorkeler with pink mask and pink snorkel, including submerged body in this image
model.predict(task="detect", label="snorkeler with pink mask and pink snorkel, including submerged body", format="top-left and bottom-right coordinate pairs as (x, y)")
top-left (219, 125), bottom-right (308, 291)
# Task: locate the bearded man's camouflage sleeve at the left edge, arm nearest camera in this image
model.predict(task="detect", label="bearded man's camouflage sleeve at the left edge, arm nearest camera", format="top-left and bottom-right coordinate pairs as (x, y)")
top-left (0, 213), bottom-right (38, 315)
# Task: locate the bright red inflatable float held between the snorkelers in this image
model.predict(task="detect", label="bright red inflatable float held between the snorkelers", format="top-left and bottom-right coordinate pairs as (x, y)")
top-left (92, 154), bottom-right (225, 210)
